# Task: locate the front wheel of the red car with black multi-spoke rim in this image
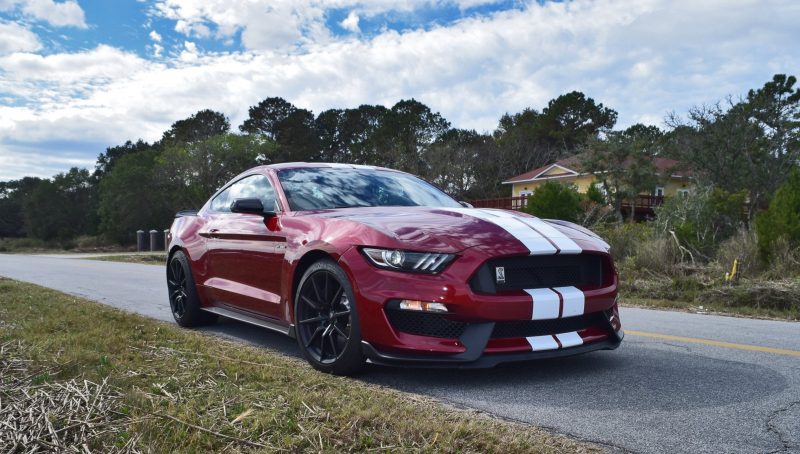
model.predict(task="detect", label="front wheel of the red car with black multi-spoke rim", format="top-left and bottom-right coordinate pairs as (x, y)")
top-left (294, 259), bottom-right (364, 375)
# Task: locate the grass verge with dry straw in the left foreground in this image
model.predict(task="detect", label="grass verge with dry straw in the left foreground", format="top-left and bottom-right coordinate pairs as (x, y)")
top-left (0, 279), bottom-right (599, 452)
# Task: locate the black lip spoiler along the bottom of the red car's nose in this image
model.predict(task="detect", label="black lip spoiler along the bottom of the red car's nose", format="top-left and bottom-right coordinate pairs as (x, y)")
top-left (361, 316), bottom-right (625, 369)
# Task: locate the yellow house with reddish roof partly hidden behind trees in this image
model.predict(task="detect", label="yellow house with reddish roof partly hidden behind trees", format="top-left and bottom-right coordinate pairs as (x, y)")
top-left (503, 155), bottom-right (692, 198)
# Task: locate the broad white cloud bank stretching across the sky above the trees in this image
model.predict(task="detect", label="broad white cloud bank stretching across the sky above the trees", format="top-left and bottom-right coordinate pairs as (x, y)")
top-left (0, 0), bottom-right (800, 181)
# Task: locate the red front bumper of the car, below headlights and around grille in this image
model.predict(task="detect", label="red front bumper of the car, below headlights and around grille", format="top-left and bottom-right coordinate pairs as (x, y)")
top-left (340, 248), bottom-right (623, 368)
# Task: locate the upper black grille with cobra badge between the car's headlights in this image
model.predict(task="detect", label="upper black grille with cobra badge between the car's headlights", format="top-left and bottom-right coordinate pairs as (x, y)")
top-left (470, 254), bottom-right (605, 293)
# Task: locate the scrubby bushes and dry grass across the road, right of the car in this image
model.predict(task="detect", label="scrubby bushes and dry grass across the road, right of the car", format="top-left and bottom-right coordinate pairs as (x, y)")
top-left (528, 172), bottom-right (800, 320)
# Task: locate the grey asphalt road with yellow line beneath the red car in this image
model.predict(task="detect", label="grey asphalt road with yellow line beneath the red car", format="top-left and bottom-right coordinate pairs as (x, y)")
top-left (0, 254), bottom-right (800, 453)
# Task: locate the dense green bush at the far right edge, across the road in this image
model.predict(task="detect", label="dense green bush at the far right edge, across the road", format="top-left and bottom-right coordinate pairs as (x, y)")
top-left (756, 170), bottom-right (800, 261)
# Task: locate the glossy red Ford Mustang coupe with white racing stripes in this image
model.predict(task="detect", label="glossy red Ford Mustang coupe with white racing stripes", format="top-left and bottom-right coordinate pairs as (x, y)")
top-left (167, 163), bottom-right (623, 374)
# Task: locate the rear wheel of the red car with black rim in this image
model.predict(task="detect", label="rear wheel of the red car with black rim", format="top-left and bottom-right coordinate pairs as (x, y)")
top-left (167, 251), bottom-right (217, 328)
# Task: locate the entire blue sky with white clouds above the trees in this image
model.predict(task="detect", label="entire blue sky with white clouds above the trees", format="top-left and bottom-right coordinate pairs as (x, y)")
top-left (0, 0), bottom-right (800, 180)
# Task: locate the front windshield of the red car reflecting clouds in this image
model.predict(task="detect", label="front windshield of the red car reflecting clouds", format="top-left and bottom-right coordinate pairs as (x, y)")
top-left (278, 167), bottom-right (461, 211)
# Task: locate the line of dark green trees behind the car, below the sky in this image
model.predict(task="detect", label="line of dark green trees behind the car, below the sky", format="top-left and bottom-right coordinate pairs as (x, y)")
top-left (0, 75), bottom-right (800, 247)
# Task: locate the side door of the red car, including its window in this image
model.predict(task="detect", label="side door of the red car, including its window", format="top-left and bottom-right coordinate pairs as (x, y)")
top-left (205, 174), bottom-right (286, 319)
